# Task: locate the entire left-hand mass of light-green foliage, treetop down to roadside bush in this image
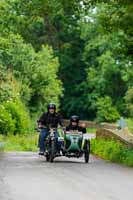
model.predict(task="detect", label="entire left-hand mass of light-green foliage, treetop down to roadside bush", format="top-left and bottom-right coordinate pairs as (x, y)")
top-left (0, 0), bottom-right (62, 134)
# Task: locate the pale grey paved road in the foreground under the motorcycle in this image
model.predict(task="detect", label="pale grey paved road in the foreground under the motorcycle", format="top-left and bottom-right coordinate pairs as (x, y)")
top-left (0, 152), bottom-right (133, 200)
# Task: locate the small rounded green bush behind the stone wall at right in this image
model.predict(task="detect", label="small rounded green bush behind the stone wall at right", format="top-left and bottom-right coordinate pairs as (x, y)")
top-left (96, 96), bottom-right (120, 122)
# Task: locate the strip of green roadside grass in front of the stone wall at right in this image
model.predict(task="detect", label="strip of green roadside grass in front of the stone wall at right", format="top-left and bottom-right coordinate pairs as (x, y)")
top-left (91, 139), bottom-right (133, 167)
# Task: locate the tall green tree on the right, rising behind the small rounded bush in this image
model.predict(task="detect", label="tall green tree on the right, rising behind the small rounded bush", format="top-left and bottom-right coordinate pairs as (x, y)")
top-left (79, 3), bottom-right (133, 119)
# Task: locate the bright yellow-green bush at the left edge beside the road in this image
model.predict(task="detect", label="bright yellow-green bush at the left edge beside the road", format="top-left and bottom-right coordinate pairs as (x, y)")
top-left (0, 101), bottom-right (31, 135)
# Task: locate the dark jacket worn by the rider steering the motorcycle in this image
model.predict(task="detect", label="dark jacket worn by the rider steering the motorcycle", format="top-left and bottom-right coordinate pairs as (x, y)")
top-left (38, 112), bottom-right (63, 128)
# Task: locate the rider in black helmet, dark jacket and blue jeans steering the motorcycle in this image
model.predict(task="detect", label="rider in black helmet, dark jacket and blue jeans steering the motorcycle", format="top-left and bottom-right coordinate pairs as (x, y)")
top-left (38, 103), bottom-right (63, 155)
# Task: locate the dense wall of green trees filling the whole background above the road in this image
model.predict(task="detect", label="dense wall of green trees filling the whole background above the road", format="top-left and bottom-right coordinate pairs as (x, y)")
top-left (0, 0), bottom-right (133, 136)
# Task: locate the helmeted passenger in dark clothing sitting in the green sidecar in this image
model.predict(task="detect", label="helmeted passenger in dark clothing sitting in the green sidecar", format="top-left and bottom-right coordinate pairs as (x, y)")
top-left (66, 115), bottom-right (86, 133)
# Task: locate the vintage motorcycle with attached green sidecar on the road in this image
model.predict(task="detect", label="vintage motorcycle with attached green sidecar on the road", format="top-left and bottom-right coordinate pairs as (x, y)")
top-left (37, 128), bottom-right (90, 163)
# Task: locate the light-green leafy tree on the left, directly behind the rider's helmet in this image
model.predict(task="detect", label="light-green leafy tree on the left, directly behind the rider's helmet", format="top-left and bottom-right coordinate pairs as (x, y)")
top-left (0, 34), bottom-right (62, 115)
